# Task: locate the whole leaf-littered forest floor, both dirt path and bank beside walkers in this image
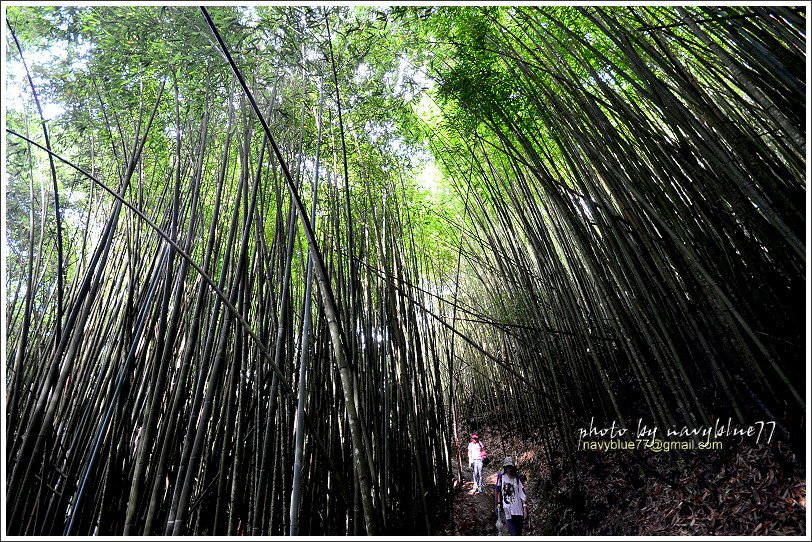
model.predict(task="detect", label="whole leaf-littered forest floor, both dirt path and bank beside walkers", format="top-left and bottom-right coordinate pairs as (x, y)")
top-left (435, 430), bottom-right (806, 536)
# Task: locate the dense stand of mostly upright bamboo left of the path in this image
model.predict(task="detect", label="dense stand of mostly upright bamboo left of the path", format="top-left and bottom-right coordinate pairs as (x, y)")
top-left (3, 8), bottom-right (449, 535)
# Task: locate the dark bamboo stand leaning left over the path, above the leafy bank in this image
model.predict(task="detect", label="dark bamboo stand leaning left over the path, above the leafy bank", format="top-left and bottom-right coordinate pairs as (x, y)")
top-left (418, 4), bottom-right (805, 470)
